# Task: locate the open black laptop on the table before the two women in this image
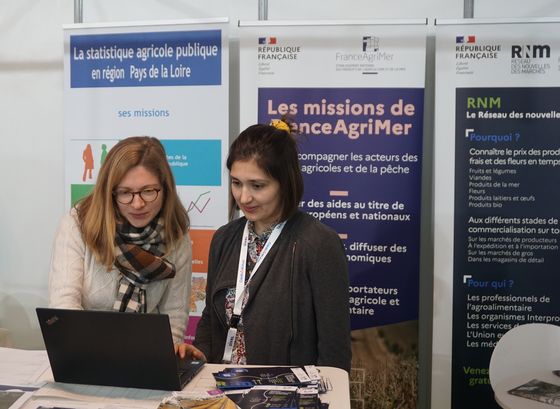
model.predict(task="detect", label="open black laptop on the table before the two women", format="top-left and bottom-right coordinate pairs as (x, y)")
top-left (36, 308), bottom-right (204, 391)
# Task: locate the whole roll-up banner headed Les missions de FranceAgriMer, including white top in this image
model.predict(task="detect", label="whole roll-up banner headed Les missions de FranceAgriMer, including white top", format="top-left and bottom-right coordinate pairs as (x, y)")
top-left (239, 20), bottom-right (426, 408)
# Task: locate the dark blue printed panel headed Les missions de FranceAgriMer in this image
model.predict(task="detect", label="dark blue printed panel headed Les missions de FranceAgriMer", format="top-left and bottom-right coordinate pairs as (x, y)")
top-left (258, 88), bottom-right (424, 329)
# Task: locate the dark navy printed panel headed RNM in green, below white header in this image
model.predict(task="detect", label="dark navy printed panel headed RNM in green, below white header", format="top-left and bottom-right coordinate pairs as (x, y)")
top-left (452, 87), bottom-right (560, 408)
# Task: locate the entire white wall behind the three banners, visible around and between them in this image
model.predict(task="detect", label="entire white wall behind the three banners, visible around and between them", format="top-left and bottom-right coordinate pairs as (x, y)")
top-left (0, 0), bottom-right (560, 409)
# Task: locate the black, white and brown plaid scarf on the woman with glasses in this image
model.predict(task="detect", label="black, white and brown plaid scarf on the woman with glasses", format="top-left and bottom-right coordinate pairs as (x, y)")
top-left (113, 217), bottom-right (175, 312)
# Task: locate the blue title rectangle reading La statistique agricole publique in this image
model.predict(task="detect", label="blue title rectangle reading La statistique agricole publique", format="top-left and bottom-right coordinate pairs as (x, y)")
top-left (70, 30), bottom-right (222, 88)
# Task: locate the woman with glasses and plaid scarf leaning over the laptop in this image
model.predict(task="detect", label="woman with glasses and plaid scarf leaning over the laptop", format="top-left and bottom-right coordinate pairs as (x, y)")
top-left (49, 137), bottom-right (204, 359)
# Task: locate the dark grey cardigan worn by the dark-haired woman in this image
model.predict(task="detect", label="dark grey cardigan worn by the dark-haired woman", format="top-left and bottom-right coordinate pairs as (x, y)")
top-left (194, 212), bottom-right (351, 371)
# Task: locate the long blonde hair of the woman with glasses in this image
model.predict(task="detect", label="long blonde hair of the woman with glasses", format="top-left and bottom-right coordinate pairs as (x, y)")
top-left (76, 136), bottom-right (189, 269)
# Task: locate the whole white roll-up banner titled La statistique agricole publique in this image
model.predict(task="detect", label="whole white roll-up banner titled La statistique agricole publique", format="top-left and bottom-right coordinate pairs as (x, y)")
top-left (64, 19), bottom-right (229, 340)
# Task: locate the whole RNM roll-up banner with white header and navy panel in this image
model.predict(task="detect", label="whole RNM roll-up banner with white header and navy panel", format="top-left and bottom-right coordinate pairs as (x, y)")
top-left (432, 19), bottom-right (560, 409)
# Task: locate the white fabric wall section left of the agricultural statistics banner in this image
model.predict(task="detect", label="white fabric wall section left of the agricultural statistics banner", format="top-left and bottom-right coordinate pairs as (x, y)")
top-left (0, 0), bottom-right (73, 348)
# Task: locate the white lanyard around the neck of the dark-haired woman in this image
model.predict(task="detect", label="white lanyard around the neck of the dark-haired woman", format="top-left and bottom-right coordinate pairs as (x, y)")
top-left (222, 221), bottom-right (286, 363)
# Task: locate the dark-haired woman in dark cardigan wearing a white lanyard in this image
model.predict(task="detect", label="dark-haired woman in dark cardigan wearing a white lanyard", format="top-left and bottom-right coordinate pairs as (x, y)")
top-left (194, 119), bottom-right (351, 371)
